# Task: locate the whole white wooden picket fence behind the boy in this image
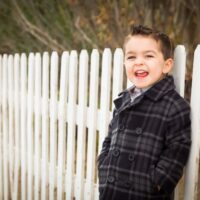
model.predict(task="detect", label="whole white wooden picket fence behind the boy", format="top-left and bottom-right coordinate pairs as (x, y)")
top-left (0, 45), bottom-right (200, 200)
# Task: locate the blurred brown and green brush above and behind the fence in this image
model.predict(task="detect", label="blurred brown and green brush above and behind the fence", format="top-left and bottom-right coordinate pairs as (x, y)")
top-left (0, 0), bottom-right (200, 100)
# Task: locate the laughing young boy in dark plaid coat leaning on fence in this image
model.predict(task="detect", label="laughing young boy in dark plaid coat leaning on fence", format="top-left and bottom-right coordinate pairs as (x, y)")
top-left (98, 25), bottom-right (191, 200)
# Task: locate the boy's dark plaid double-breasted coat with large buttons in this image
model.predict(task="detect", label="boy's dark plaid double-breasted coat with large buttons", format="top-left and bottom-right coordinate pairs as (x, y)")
top-left (98, 76), bottom-right (191, 200)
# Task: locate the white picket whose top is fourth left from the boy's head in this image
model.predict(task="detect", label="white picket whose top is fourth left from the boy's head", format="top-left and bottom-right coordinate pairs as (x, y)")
top-left (75, 50), bottom-right (88, 200)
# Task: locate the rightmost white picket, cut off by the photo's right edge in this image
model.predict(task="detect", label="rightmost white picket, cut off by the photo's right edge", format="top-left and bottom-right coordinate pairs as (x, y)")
top-left (184, 45), bottom-right (200, 200)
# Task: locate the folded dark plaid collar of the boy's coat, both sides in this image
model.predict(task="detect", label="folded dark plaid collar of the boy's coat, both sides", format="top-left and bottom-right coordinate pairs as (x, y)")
top-left (114, 75), bottom-right (175, 109)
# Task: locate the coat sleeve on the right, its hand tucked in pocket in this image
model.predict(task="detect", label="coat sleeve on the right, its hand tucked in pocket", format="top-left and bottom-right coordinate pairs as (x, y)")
top-left (150, 101), bottom-right (191, 193)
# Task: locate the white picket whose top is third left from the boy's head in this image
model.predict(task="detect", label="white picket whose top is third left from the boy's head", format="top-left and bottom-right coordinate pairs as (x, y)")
top-left (84, 49), bottom-right (99, 200)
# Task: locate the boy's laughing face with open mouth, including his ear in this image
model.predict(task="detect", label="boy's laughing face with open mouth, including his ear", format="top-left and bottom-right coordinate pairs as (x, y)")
top-left (124, 35), bottom-right (173, 88)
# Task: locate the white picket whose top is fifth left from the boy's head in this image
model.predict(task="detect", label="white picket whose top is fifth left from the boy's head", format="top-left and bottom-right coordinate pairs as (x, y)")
top-left (65, 51), bottom-right (78, 200)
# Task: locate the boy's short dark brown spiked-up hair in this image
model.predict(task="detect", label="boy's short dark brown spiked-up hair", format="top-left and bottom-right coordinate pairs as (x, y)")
top-left (124, 25), bottom-right (174, 60)
